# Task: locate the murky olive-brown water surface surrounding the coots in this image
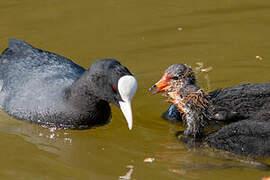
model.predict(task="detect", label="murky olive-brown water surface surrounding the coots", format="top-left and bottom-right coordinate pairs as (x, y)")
top-left (0, 0), bottom-right (270, 180)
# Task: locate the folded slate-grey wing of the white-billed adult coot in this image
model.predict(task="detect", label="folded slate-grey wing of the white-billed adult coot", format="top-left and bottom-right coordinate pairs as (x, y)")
top-left (0, 39), bottom-right (85, 112)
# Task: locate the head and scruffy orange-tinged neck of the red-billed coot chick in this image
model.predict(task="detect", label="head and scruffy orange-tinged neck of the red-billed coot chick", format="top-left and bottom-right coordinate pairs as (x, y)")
top-left (151, 64), bottom-right (210, 139)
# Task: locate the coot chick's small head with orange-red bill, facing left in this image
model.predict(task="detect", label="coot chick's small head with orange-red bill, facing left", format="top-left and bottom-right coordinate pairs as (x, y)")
top-left (150, 63), bottom-right (196, 94)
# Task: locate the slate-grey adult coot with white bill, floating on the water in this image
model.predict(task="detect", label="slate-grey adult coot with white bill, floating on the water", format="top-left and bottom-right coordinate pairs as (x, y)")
top-left (0, 39), bottom-right (137, 129)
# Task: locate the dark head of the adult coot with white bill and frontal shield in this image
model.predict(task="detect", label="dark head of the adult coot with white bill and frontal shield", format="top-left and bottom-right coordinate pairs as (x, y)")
top-left (89, 59), bottom-right (137, 129)
